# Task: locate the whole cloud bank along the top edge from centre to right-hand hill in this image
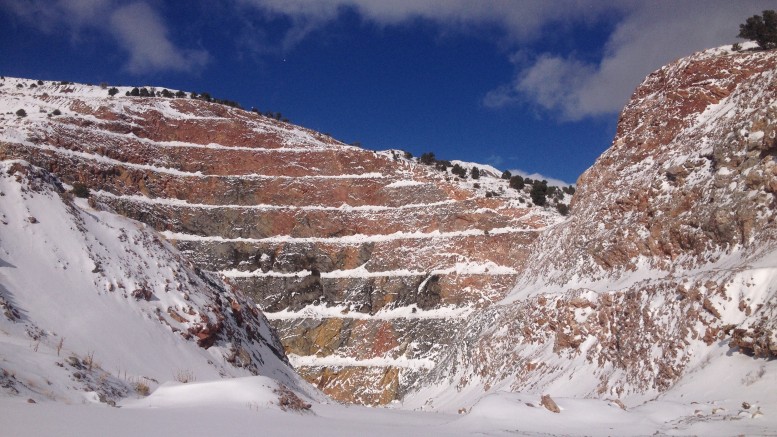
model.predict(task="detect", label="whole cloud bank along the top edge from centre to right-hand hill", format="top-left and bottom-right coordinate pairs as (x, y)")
top-left (239, 0), bottom-right (774, 120)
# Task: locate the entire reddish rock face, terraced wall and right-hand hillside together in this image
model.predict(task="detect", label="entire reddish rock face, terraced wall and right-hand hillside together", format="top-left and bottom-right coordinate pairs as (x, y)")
top-left (0, 42), bottom-right (777, 410)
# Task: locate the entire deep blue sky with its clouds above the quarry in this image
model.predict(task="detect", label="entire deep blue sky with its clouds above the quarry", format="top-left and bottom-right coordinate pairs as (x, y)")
top-left (0, 0), bottom-right (775, 182)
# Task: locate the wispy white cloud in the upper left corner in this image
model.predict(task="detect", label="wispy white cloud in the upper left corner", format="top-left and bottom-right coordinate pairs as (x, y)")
top-left (0, 0), bottom-right (208, 73)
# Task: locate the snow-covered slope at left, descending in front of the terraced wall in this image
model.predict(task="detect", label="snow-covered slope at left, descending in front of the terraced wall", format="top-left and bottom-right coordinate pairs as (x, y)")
top-left (0, 161), bottom-right (317, 403)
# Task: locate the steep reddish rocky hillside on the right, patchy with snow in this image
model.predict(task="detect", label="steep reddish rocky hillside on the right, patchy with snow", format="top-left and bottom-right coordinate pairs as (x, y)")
top-left (409, 44), bottom-right (777, 406)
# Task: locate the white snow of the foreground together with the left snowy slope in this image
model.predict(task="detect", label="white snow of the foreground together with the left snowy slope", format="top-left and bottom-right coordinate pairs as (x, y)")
top-left (0, 161), bottom-right (777, 436)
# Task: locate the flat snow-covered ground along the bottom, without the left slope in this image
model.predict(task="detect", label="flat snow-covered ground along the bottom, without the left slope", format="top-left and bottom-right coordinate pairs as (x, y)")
top-left (0, 355), bottom-right (777, 436)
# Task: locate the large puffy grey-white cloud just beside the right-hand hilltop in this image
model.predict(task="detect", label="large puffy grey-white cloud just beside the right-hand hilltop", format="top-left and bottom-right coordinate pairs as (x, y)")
top-left (483, 1), bottom-right (767, 120)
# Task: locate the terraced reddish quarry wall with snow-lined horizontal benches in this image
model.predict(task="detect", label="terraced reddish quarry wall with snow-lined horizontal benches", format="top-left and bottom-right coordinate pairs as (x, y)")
top-left (0, 78), bottom-right (569, 404)
